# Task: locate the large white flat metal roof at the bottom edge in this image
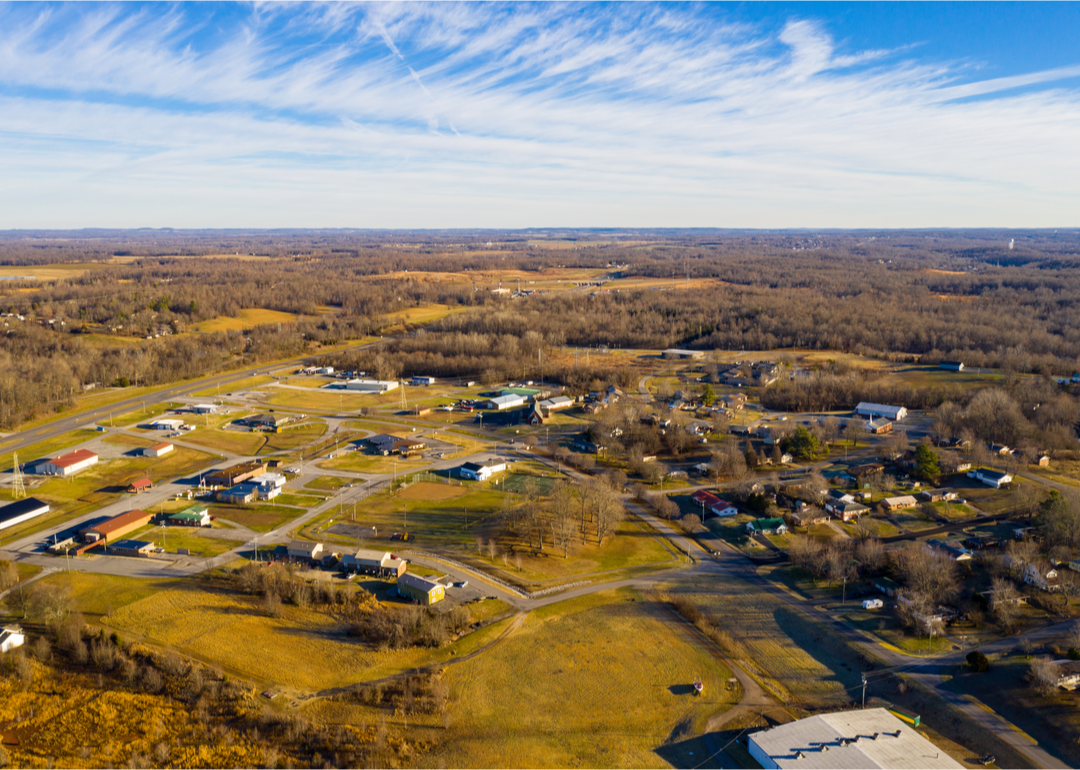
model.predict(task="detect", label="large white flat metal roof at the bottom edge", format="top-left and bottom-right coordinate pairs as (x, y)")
top-left (750, 708), bottom-right (963, 770)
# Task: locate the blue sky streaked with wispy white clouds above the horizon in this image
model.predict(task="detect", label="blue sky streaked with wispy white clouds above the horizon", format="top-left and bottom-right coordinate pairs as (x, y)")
top-left (0, 2), bottom-right (1080, 229)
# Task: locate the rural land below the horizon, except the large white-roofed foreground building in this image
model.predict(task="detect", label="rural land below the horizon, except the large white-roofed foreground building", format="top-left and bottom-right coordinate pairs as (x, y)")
top-left (0, 230), bottom-right (1080, 768)
